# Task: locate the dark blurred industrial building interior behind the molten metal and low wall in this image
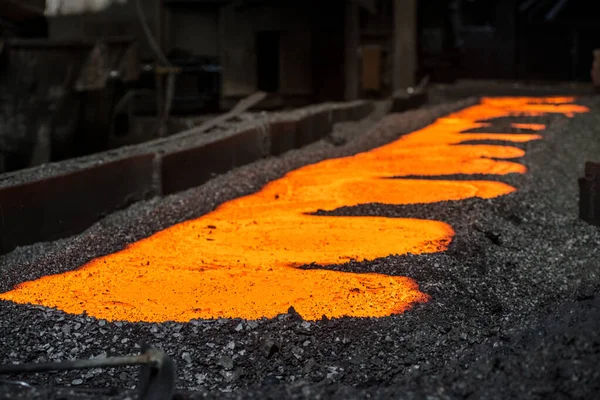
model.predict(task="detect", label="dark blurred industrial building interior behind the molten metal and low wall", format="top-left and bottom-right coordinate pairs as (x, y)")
top-left (0, 0), bottom-right (600, 171)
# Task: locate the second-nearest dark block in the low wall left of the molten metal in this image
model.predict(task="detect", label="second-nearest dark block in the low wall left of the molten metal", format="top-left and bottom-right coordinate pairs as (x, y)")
top-left (161, 128), bottom-right (267, 195)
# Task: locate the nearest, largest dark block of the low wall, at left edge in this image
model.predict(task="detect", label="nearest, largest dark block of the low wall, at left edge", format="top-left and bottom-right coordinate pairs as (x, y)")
top-left (0, 154), bottom-right (157, 254)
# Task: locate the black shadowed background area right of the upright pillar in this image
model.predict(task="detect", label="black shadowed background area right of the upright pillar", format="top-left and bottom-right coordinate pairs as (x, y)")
top-left (418, 0), bottom-right (600, 81)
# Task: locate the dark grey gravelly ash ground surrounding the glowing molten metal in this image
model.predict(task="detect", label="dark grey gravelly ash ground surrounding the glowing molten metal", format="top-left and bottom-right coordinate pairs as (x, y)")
top-left (0, 97), bottom-right (600, 399)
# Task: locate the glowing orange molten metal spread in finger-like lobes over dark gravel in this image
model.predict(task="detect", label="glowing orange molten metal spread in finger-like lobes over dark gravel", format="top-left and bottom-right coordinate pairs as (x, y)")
top-left (0, 98), bottom-right (587, 322)
